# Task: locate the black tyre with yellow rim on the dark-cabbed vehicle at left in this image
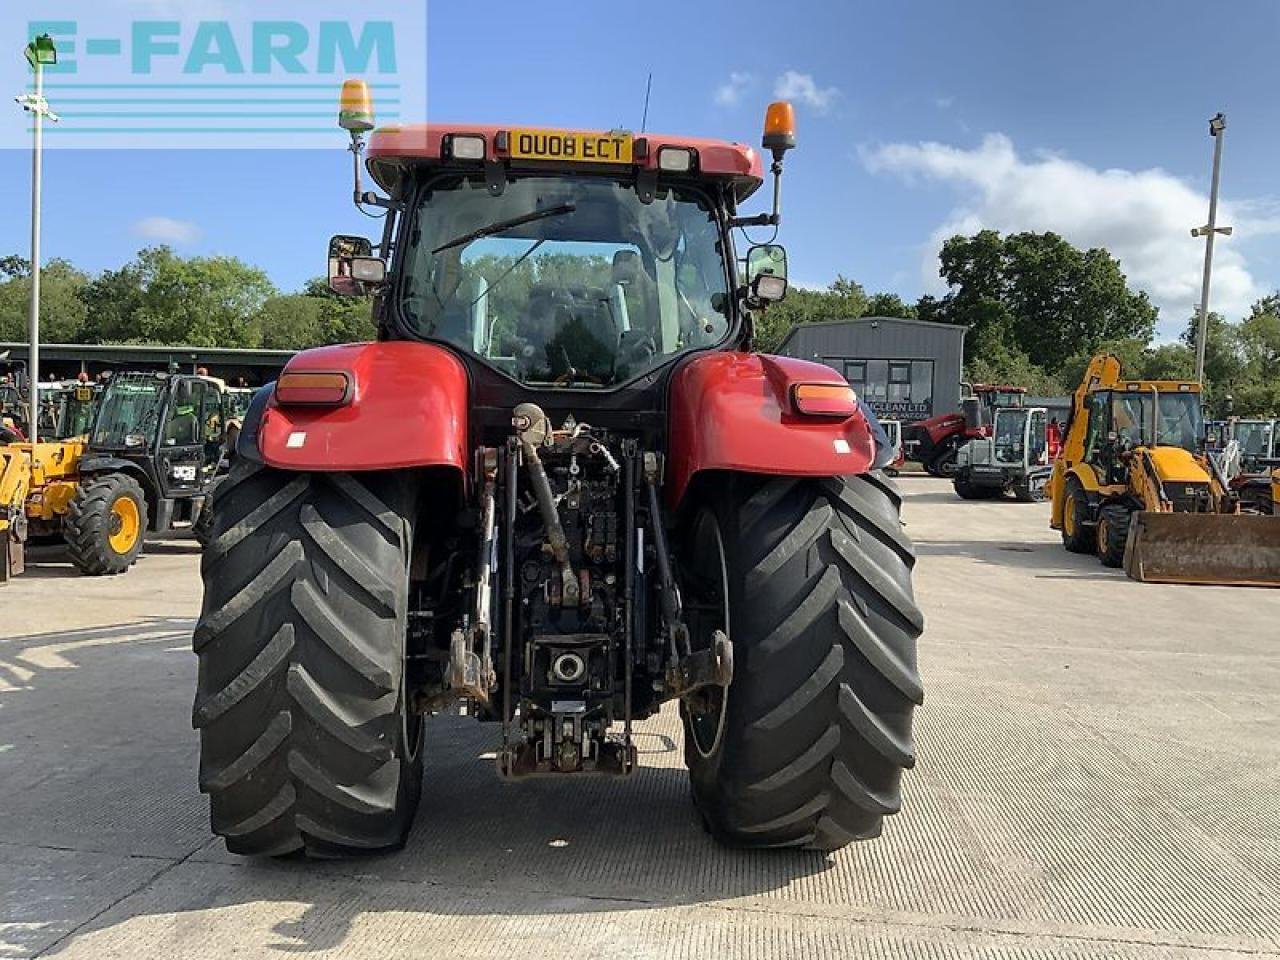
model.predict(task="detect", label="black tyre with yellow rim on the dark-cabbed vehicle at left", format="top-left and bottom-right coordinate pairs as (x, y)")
top-left (63, 474), bottom-right (147, 576)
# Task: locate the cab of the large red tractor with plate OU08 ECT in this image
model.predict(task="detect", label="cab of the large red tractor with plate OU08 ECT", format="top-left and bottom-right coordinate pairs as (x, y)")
top-left (329, 106), bottom-right (791, 434)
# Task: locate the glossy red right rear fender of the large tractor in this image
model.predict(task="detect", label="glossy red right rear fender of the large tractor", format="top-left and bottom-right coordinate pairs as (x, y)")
top-left (667, 353), bottom-right (877, 507)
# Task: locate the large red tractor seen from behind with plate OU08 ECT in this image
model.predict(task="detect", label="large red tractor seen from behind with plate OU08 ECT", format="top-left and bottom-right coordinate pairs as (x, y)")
top-left (193, 82), bottom-right (923, 856)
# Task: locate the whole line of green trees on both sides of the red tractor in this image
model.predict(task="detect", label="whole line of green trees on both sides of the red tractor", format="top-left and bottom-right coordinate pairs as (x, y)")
top-left (0, 230), bottom-right (1280, 416)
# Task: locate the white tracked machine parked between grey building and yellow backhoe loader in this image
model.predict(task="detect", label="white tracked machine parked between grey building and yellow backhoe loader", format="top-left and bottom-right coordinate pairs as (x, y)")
top-left (952, 407), bottom-right (1052, 503)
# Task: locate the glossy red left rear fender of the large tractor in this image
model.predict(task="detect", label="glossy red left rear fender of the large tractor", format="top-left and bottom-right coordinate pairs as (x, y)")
top-left (253, 340), bottom-right (470, 476)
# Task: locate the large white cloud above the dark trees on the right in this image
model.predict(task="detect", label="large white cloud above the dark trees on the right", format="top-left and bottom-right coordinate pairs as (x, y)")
top-left (863, 133), bottom-right (1280, 337)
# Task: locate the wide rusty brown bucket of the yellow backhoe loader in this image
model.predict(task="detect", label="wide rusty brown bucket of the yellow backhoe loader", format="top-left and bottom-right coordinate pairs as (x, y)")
top-left (1124, 512), bottom-right (1280, 586)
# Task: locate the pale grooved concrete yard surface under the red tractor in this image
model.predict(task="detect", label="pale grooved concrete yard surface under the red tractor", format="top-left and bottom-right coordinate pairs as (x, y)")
top-left (0, 476), bottom-right (1280, 960)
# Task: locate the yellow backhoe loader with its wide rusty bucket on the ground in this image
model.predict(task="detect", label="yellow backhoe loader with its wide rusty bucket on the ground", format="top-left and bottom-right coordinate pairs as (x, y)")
top-left (1050, 355), bottom-right (1280, 586)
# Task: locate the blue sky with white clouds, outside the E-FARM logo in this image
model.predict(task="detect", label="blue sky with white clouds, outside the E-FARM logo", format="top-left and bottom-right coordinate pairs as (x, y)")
top-left (0, 0), bottom-right (1280, 333)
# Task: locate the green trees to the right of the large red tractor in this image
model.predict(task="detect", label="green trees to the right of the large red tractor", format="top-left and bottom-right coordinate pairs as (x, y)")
top-left (756, 230), bottom-right (1280, 416)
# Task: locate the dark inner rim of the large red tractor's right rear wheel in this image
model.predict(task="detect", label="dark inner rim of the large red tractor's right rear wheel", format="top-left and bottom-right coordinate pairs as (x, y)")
top-left (686, 511), bottom-right (733, 758)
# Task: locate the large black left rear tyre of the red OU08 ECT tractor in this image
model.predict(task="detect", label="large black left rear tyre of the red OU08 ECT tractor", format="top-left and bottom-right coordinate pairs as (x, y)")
top-left (192, 460), bottom-right (422, 858)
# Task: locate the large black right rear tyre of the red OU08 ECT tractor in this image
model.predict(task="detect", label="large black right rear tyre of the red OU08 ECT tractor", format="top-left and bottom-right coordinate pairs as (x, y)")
top-left (685, 474), bottom-right (924, 851)
